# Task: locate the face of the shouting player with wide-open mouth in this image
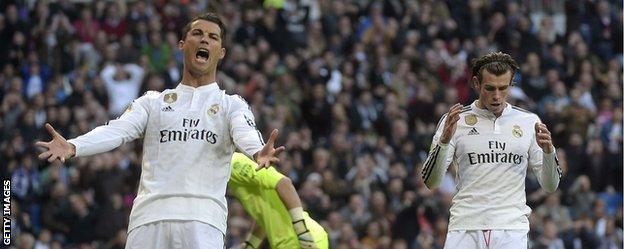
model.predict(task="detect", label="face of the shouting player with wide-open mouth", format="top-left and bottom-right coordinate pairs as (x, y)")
top-left (178, 20), bottom-right (225, 74)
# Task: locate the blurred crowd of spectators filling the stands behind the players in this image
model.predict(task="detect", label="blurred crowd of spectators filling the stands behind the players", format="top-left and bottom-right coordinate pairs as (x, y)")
top-left (0, 0), bottom-right (623, 249)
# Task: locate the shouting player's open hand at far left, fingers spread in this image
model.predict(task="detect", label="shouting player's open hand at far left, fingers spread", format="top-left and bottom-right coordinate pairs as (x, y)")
top-left (35, 123), bottom-right (76, 163)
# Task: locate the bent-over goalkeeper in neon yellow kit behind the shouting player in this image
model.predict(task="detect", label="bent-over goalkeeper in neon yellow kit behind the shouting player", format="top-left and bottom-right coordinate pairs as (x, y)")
top-left (228, 153), bottom-right (329, 249)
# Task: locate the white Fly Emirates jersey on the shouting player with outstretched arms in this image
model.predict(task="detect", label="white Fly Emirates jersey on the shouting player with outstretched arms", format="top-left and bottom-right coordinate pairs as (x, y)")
top-left (69, 83), bottom-right (264, 234)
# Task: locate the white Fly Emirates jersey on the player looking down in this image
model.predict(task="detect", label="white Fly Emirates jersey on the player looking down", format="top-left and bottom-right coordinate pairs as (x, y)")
top-left (423, 102), bottom-right (561, 231)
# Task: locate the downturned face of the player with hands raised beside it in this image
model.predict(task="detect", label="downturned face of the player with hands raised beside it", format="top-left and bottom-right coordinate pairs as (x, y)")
top-left (473, 70), bottom-right (512, 116)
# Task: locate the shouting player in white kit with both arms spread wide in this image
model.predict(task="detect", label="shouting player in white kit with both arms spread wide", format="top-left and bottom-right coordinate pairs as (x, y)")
top-left (37, 13), bottom-right (284, 249)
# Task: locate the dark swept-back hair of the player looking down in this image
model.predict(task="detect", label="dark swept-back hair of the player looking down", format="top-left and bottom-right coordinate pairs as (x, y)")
top-left (471, 52), bottom-right (520, 83)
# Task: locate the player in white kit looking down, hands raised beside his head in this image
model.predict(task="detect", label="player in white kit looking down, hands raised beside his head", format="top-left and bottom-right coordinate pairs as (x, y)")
top-left (422, 53), bottom-right (561, 248)
